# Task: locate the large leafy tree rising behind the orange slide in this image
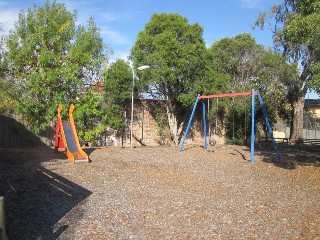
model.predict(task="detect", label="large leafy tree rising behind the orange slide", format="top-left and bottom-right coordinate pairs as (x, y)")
top-left (5, 1), bottom-right (106, 133)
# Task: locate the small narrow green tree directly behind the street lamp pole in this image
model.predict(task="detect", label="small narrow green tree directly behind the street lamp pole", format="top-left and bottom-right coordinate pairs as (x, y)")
top-left (104, 59), bottom-right (133, 129)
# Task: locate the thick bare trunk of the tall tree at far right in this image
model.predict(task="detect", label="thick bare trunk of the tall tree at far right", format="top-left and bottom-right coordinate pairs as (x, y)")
top-left (290, 97), bottom-right (304, 143)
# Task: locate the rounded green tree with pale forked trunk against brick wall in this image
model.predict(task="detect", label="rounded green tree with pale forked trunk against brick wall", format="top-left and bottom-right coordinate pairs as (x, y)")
top-left (131, 13), bottom-right (207, 144)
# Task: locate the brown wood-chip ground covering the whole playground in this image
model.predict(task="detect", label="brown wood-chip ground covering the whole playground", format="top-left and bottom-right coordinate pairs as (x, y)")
top-left (0, 145), bottom-right (320, 239)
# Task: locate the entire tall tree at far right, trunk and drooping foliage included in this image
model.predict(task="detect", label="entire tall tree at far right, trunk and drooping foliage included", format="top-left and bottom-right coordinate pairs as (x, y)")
top-left (256, 0), bottom-right (320, 142)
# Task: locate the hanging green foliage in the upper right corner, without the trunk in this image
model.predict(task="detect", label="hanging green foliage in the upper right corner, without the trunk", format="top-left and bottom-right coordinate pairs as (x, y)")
top-left (283, 0), bottom-right (320, 94)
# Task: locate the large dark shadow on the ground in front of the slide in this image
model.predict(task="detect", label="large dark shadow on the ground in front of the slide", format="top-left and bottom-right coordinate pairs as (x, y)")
top-left (0, 148), bottom-right (92, 239)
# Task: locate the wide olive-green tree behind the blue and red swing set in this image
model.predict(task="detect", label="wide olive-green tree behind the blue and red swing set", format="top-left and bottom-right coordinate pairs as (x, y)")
top-left (209, 33), bottom-right (296, 142)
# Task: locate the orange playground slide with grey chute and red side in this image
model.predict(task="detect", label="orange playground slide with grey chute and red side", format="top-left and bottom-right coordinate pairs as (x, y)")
top-left (54, 104), bottom-right (89, 164)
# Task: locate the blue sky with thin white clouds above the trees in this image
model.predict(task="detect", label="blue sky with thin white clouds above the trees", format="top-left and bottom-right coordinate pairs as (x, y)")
top-left (0, 0), bottom-right (318, 98)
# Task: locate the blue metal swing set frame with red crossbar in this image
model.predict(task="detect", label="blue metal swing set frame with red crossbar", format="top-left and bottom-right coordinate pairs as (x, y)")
top-left (180, 89), bottom-right (281, 164)
